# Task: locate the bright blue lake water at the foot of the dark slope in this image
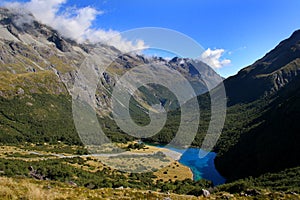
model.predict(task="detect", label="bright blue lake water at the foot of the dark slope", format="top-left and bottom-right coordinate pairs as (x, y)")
top-left (157, 146), bottom-right (226, 185)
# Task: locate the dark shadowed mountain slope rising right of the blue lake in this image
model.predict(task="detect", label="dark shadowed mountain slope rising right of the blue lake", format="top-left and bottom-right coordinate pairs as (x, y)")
top-left (215, 31), bottom-right (300, 180)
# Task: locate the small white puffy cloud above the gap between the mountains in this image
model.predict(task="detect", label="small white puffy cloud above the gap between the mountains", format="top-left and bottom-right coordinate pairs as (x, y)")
top-left (199, 48), bottom-right (231, 69)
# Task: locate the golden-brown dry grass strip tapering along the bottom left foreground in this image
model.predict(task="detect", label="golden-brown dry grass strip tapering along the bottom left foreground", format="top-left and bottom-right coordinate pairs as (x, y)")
top-left (0, 177), bottom-right (202, 200)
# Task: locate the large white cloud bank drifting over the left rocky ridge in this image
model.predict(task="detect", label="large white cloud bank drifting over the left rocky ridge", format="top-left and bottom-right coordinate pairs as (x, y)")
top-left (5, 0), bottom-right (146, 52)
